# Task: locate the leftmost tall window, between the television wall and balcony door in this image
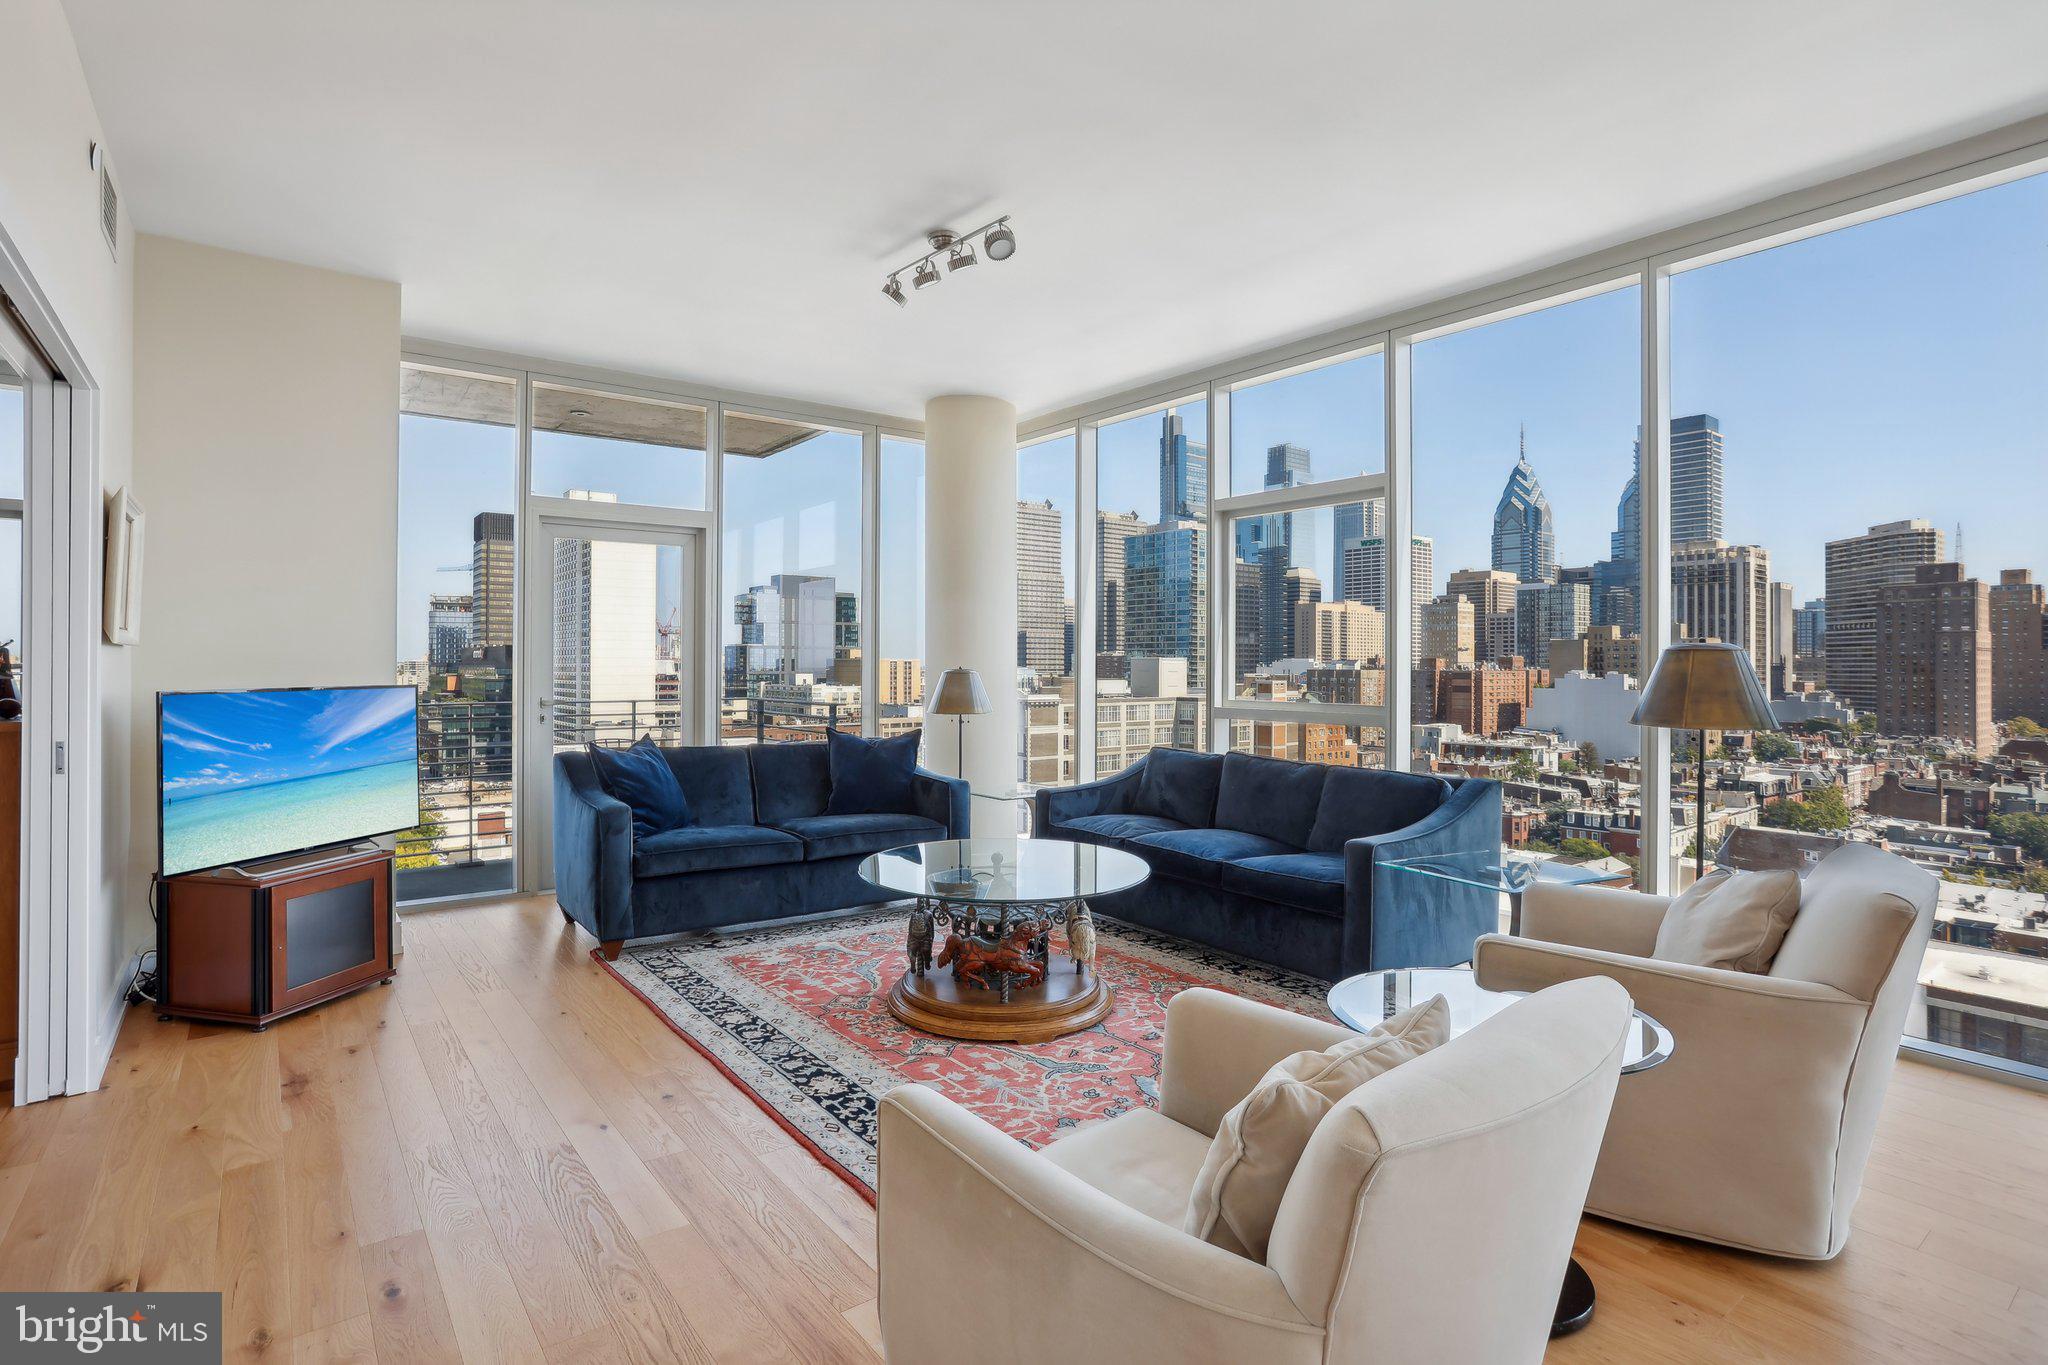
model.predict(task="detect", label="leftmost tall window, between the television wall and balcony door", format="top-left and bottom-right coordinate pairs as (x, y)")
top-left (397, 364), bottom-right (518, 900)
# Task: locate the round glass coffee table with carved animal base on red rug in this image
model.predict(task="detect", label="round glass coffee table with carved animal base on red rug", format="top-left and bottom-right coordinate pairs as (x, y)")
top-left (860, 839), bottom-right (1151, 1044)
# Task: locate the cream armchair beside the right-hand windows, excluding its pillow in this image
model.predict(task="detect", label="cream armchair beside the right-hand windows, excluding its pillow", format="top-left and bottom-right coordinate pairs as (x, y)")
top-left (1473, 843), bottom-right (1937, 1259)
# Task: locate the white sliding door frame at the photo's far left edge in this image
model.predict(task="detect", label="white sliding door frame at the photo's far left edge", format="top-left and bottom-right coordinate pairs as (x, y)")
top-left (0, 225), bottom-right (101, 1105)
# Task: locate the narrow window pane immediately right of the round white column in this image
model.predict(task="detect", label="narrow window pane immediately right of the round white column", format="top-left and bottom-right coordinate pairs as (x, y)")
top-left (1016, 432), bottom-right (1079, 796)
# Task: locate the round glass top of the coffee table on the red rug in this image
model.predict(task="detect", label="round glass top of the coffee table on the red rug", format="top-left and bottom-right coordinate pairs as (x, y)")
top-left (860, 839), bottom-right (1151, 905)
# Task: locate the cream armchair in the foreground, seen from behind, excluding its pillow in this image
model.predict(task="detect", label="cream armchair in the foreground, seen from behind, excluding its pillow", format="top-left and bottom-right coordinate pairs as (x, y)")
top-left (879, 980), bottom-right (1630, 1365)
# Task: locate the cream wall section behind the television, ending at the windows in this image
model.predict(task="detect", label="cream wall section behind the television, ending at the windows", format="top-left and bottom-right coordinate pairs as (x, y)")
top-left (129, 235), bottom-right (399, 941)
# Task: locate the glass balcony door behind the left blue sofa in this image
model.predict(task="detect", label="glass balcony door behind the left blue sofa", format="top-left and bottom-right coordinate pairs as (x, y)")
top-left (520, 509), bottom-right (707, 890)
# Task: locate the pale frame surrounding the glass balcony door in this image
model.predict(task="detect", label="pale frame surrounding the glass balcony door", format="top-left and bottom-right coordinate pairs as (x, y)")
top-left (512, 505), bottom-right (717, 892)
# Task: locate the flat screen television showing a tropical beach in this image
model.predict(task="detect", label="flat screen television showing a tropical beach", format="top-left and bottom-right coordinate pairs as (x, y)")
top-left (156, 686), bottom-right (420, 876)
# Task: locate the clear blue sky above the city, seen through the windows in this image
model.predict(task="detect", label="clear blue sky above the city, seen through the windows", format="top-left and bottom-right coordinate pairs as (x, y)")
top-left (391, 167), bottom-right (2048, 671)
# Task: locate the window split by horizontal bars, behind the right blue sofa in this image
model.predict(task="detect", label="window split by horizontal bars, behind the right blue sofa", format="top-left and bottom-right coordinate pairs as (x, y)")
top-left (1219, 350), bottom-right (1389, 767)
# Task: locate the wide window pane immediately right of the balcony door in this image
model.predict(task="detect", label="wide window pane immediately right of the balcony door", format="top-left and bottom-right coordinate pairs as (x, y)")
top-left (719, 409), bottom-right (862, 743)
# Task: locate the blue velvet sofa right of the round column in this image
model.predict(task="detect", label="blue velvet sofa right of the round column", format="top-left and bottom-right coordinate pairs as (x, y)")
top-left (1032, 749), bottom-right (1501, 980)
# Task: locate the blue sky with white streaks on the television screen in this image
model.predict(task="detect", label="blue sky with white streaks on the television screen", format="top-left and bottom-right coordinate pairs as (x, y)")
top-left (164, 688), bottom-right (418, 798)
